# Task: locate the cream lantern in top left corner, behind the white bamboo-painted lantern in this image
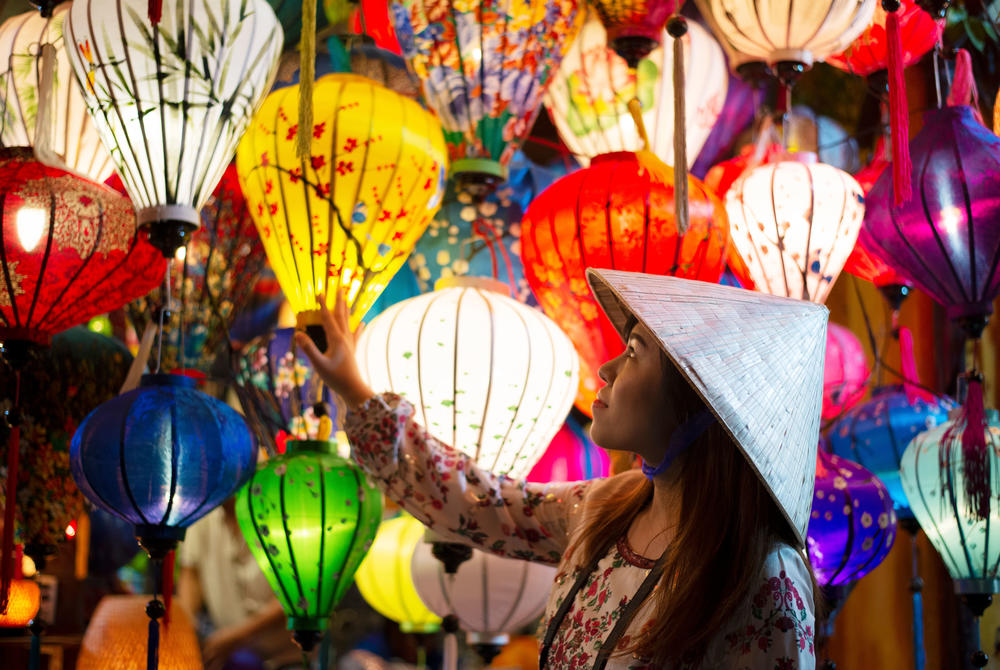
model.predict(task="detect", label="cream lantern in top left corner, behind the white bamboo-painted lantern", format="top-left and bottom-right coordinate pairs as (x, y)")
top-left (0, 2), bottom-right (114, 182)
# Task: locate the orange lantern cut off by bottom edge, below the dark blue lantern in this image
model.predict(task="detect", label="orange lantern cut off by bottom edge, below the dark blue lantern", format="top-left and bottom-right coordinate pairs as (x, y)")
top-left (76, 596), bottom-right (202, 670)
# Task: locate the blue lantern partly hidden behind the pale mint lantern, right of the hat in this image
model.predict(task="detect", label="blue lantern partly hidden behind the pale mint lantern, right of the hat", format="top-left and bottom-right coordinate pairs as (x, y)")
top-left (829, 386), bottom-right (955, 518)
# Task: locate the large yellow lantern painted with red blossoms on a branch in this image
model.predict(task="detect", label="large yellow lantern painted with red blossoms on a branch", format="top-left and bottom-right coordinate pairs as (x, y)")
top-left (236, 74), bottom-right (447, 327)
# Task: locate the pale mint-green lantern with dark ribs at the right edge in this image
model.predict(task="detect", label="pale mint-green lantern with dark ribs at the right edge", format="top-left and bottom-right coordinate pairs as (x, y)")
top-left (899, 409), bottom-right (1000, 593)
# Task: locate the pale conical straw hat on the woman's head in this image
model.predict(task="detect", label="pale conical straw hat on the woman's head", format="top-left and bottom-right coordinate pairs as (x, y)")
top-left (587, 269), bottom-right (829, 546)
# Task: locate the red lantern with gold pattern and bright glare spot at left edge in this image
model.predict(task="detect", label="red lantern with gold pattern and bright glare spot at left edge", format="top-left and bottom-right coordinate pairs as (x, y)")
top-left (0, 148), bottom-right (164, 352)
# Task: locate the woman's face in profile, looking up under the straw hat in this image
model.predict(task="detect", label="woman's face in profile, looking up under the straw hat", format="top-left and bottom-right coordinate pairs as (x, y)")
top-left (590, 323), bottom-right (683, 464)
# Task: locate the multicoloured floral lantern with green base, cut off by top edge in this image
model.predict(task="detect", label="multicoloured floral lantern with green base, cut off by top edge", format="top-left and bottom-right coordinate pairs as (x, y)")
top-left (391, 0), bottom-right (583, 195)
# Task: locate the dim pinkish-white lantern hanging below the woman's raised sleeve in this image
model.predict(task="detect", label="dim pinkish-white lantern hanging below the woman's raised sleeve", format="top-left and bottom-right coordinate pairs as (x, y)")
top-left (411, 542), bottom-right (556, 646)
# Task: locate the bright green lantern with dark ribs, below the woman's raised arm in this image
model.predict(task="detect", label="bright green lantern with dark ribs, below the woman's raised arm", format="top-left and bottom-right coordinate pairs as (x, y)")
top-left (236, 440), bottom-right (382, 651)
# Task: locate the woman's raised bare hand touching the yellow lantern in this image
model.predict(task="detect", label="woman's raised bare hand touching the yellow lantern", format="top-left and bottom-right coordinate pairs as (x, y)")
top-left (295, 291), bottom-right (375, 408)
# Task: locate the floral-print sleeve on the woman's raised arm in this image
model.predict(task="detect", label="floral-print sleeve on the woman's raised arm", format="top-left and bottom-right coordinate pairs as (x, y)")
top-left (345, 393), bottom-right (590, 565)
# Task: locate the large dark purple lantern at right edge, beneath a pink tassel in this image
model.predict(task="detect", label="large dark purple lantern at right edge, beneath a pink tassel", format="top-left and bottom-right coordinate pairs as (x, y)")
top-left (865, 105), bottom-right (1000, 338)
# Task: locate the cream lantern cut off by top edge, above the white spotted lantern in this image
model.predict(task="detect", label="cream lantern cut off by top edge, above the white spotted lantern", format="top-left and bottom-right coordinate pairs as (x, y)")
top-left (695, 0), bottom-right (878, 73)
